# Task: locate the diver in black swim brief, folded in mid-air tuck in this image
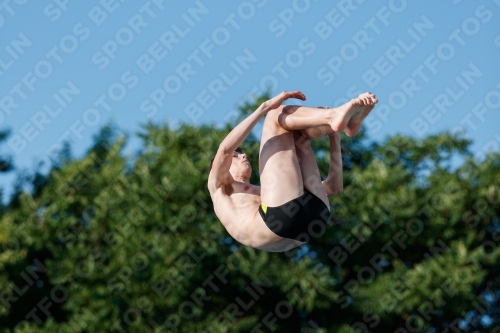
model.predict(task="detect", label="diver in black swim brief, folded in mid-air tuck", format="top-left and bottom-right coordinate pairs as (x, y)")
top-left (207, 91), bottom-right (377, 252)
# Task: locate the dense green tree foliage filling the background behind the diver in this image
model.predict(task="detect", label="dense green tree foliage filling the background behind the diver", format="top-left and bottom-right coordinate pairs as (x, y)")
top-left (0, 97), bottom-right (500, 333)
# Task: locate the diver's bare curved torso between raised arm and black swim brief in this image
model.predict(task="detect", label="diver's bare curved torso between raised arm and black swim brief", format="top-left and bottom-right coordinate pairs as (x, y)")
top-left (209, 181), bottom-right (304, 252)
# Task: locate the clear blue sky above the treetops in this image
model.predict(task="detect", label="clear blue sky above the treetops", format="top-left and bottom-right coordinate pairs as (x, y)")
top-left (0, 0), bottom-right (500, 202)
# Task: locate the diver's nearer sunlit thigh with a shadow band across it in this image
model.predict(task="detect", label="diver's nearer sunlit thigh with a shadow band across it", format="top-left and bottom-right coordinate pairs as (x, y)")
top-left (259, 107), bottom-right (304, 207)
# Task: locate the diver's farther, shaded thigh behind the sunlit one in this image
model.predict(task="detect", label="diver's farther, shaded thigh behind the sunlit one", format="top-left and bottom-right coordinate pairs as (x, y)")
top-left (294, 131), bottom-right (330, 207)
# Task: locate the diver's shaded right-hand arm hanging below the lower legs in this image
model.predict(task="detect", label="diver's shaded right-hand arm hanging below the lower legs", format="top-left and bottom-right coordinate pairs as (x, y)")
top-left (323, 132), bottom-right (344, 196)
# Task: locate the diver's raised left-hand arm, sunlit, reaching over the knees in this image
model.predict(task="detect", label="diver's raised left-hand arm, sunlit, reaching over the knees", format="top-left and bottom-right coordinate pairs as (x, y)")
top-left (209, 91), bottom-right (306, 188)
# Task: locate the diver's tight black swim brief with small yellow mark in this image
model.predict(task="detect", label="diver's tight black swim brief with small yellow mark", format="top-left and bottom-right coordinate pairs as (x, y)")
top-left (259, 189), bottom-right (330, 242)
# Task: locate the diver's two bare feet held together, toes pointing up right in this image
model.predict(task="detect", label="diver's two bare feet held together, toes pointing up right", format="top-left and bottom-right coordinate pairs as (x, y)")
top-left (331, 92), bottom-right (378, 136)
